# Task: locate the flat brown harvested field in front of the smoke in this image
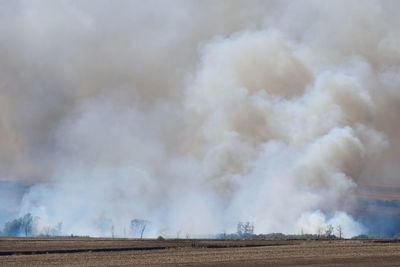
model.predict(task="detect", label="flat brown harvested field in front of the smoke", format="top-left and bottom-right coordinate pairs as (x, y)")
top-left (0, 238), bottom-right (400, 266)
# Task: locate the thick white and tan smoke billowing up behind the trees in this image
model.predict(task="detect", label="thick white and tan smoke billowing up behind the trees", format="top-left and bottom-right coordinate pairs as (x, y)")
top-left (0, 0), bottom-right (400, 237)
